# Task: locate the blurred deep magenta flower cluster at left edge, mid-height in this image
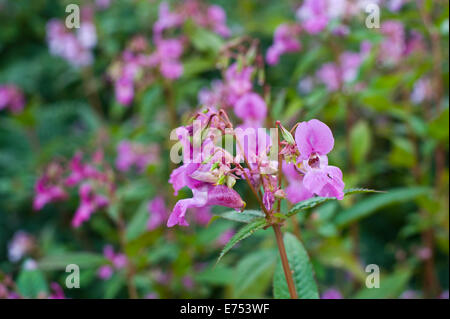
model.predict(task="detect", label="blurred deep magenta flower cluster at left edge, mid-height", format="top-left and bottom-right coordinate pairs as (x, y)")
top-left (33, 151), bottom-right (115, 227)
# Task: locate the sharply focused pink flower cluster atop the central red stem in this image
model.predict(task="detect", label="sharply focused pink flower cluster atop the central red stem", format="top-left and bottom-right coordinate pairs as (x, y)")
top-left (167, 105), bottom-right (344, 227)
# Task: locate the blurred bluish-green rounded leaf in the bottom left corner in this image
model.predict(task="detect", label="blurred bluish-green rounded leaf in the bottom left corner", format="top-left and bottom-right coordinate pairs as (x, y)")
top-left (17, 269), bottom-right (48, 298)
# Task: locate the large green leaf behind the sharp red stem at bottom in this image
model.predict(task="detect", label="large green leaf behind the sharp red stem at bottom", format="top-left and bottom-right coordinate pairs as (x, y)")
top-left (273, 233), bottom-right (319, 299)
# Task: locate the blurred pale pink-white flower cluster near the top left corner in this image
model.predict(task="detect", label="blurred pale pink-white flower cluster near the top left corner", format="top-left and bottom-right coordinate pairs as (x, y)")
top-left (47, 6), bottom-right (97, 67)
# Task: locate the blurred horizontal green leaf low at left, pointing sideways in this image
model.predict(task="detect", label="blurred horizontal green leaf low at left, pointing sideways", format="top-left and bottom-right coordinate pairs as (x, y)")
top-left (38, 253), bottom-right (108, 270)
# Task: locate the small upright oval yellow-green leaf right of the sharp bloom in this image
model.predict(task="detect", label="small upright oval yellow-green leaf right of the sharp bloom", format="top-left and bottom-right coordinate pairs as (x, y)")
top-left (350, 121), bottom-right (371, 165)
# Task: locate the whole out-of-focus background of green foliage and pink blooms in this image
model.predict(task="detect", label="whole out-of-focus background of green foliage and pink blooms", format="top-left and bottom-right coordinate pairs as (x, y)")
top-left (0, 0), bottom-right (449, 298)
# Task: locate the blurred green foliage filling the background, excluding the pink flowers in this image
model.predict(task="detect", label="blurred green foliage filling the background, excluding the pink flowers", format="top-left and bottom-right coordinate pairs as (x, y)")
top-left (0, 0), bottom-right (449, 298)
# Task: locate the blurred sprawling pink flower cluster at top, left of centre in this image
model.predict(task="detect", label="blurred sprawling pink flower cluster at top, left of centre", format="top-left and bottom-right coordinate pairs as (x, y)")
top-left (109, 0), bottom-right (230, 106)
